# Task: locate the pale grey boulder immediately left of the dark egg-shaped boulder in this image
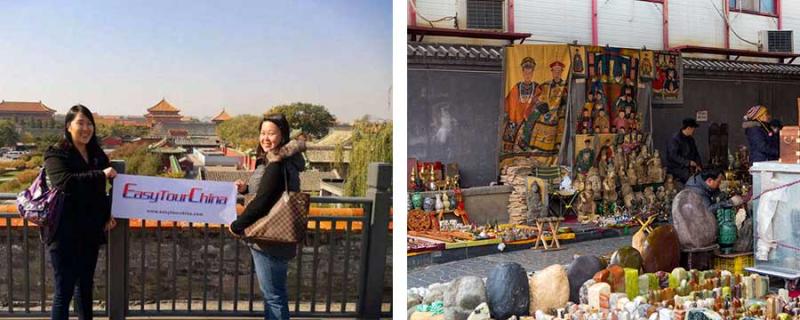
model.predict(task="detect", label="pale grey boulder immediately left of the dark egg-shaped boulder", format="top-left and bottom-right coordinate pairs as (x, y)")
top-left (444, 276), bottom-right (486, 320)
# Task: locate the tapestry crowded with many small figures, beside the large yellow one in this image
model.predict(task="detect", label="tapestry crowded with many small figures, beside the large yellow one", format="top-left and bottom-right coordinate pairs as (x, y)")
top-left (576, 47), bottom-right (641, 134)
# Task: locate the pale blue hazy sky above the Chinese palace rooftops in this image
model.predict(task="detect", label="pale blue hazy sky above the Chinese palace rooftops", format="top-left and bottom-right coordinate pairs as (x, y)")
top-left (0, 0), bottom-right (392, 121)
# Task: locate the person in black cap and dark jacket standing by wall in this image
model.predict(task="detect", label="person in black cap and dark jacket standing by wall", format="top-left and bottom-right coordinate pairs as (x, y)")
top-left (666, 118), bottom-right (702, 183)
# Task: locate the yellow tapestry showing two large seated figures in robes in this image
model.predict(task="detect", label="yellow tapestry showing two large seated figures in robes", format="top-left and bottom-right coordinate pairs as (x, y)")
top-left (500, 45), bottom-right (572, 169)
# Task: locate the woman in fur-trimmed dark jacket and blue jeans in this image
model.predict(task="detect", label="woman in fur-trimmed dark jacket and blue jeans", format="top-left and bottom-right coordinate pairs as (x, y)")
top-left (230, 114), bottom-right (305, 320)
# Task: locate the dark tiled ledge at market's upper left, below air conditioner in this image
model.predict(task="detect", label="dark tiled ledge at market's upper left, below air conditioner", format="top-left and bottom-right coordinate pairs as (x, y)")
top-left (406, 42), bottom-right (504, 62)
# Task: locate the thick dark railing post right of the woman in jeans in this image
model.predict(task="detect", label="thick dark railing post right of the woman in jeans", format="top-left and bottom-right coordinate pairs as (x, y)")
top-left (359, 163), bottom-right (392, 319)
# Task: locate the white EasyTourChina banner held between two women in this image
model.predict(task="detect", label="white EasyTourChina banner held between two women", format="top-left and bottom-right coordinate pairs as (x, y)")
top-left (111, 174), bottom-right (236, 224)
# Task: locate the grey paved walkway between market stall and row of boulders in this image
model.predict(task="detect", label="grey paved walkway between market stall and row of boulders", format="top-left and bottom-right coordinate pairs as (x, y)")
top-left (408, 236), bottom-right (631, 288)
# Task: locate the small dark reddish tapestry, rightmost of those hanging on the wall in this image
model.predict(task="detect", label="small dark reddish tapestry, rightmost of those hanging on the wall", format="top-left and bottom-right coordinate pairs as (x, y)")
top-left (653, 51), bottom-right (683, 104)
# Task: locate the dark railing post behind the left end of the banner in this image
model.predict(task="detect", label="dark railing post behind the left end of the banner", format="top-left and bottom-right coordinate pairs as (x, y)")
top-left (106, 160), bottom-right (128, 320)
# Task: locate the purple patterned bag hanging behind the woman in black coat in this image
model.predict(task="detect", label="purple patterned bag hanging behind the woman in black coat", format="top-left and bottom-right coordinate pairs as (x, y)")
top-left (17, 168), bottom-right (64, 243)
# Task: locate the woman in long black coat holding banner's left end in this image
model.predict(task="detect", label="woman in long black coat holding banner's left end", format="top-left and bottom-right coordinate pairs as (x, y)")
top-left (44, 105), bottom-right (117, 320)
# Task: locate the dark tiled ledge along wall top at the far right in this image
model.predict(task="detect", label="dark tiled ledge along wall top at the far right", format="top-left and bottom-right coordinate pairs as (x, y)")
top-left (683, 58), bottom-right (800, 75)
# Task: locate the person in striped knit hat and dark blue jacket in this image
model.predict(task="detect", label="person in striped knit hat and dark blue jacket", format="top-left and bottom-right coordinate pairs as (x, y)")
top-left (742, 105), bottom-right (780, 165)
